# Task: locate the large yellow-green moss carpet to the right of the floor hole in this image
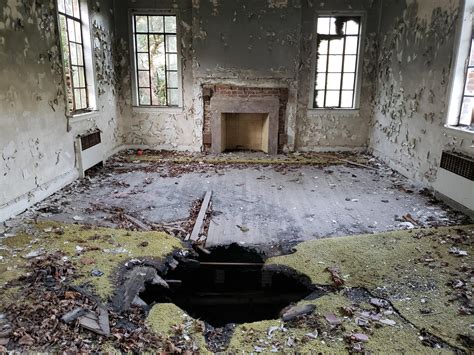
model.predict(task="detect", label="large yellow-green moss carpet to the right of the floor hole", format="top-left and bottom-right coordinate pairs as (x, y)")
top-left (267, 226), bottom-right (474, 348)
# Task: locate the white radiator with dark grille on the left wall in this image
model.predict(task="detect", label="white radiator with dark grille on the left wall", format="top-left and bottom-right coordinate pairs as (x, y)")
top-left (76, 131), bottom-right (104, 178)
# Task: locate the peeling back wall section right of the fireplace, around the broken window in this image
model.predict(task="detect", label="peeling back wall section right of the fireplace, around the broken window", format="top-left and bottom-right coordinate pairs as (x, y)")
top-left (296, 0), bottom-right (379, 151)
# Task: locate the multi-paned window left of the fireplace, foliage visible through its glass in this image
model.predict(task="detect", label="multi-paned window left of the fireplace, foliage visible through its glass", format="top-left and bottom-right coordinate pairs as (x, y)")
top-left (133, 15), bottom-right (179, 106)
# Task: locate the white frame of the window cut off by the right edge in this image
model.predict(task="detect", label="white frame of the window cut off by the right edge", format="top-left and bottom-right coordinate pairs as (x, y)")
top-left (444, 0), bottom-right (474, 134)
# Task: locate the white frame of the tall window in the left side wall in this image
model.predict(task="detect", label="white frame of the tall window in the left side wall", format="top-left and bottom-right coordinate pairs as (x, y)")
top-left (55, 0), bottom-right (97, 117)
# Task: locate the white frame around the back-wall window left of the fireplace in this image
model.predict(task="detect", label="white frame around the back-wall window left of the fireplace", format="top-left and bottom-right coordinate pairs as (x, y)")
top-left (128, 9), bottom-right (183, 111)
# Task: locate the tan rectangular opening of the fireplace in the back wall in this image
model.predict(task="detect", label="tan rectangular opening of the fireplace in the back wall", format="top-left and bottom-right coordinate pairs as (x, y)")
top-left (221, 113), bottom-right (269, 153)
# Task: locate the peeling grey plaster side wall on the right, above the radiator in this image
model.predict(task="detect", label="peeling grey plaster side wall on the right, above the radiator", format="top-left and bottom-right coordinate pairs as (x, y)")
top-left (370, 0), bottom-right (473, 185)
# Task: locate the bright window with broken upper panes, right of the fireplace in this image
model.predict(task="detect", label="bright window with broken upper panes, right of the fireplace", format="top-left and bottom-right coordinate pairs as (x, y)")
top-left (313, 16), bottom-right (361, 109)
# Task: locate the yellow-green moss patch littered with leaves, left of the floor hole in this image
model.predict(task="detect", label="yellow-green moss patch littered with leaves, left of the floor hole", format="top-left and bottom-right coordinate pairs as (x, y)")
top-left (0, 222), bottom-right (183, 299)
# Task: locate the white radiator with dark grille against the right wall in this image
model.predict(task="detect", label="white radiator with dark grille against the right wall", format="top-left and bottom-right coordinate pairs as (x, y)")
top-left (434, 152), bottom-right (474, 211)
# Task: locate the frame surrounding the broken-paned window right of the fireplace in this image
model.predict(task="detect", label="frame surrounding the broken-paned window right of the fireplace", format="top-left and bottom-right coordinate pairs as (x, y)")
top-left (308, 11), bottom-right (367, 113)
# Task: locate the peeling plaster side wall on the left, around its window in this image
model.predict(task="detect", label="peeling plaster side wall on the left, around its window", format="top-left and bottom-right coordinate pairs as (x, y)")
top-left (0, 0), bottom-right (121, 221)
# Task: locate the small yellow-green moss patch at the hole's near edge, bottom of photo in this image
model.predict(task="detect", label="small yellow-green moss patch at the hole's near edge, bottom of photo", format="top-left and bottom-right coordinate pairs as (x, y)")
top-left (146, 303), bottom-right (210, 354)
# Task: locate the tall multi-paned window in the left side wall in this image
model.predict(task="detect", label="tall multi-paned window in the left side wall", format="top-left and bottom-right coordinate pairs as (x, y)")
top-left (58, 0), bottom-right (89, 112)
